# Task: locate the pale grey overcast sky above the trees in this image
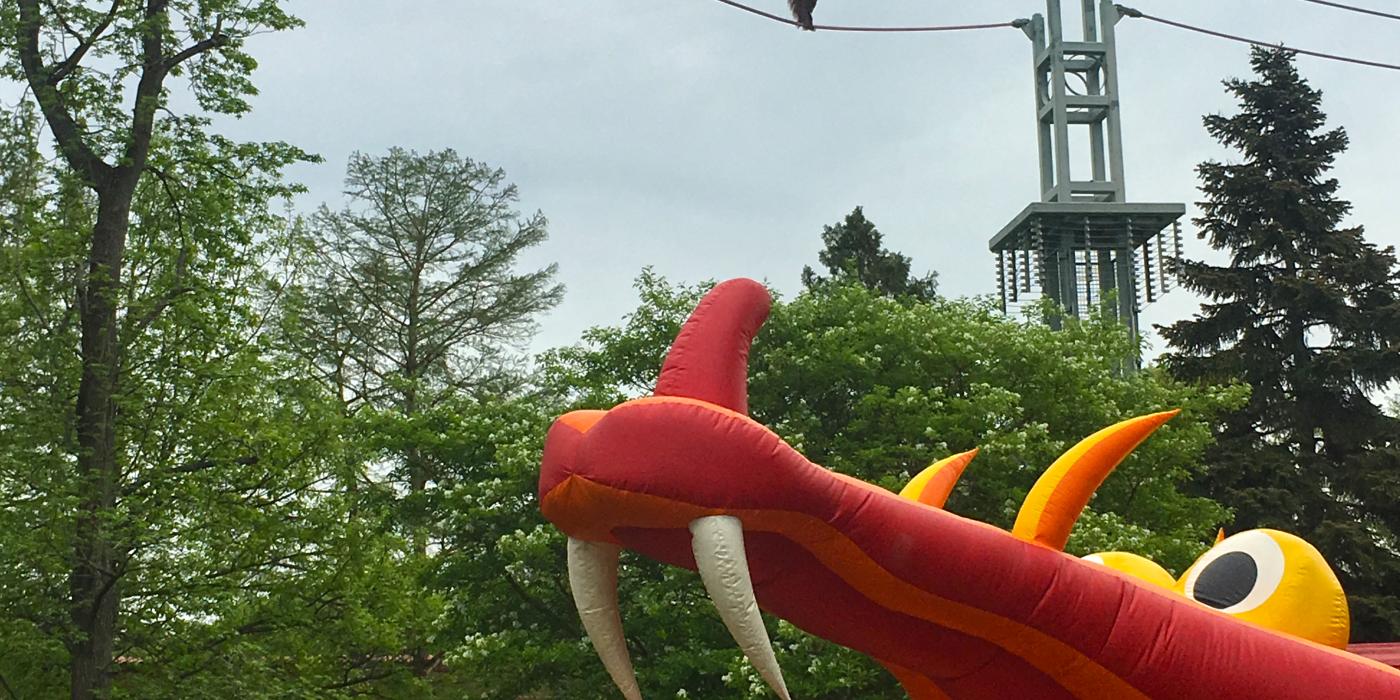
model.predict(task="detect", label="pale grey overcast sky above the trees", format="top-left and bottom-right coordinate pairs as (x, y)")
top-left (51, 0), bottom-right (1400, 350)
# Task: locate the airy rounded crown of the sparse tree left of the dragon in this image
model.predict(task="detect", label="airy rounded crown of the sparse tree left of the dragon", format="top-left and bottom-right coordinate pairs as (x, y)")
top-left (302, 148), bottom-right (563, 417)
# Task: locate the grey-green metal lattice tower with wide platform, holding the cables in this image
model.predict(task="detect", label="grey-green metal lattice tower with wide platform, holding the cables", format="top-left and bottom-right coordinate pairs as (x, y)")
top-left (988, 0), bottom-right (1186, 337)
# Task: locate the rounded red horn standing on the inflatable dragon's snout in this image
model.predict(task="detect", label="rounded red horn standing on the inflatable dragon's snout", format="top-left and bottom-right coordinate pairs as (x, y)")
top-left (657, 279), bottom-right (773, 414)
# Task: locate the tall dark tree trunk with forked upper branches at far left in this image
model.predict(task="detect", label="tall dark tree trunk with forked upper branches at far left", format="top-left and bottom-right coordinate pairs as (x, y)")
top-left (13, 0), bottom-right (235, 700)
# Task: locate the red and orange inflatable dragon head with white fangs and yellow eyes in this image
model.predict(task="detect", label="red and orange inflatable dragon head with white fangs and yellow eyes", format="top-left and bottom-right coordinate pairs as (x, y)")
top-left (540, 280), bottom-right (1400, 700)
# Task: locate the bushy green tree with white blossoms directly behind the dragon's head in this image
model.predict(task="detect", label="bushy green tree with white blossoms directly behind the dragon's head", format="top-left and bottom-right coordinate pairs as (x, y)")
top-left (442, 273), bottom-right (1243, 700)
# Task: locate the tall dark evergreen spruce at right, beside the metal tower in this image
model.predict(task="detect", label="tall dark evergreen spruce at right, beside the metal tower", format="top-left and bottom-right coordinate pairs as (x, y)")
top-left (1161, 49), bottom-right (1400, 641)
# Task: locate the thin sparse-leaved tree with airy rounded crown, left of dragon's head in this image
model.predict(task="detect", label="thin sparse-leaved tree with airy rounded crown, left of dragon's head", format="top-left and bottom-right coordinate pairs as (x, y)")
top-left (278, 148), bottom-right (563, 696)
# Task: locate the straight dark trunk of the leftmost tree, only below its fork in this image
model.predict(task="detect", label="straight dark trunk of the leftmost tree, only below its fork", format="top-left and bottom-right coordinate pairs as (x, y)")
top-left (69, 183), bottom-right (134, 700)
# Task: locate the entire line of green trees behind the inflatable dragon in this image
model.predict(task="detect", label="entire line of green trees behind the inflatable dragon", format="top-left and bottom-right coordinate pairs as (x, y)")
top-left (0, 0), bottom-right (1400, 700)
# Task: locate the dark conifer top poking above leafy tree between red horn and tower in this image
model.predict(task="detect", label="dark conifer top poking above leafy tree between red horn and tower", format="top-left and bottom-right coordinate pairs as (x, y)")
top-left (802, 207), bottom-right (938, 301)
